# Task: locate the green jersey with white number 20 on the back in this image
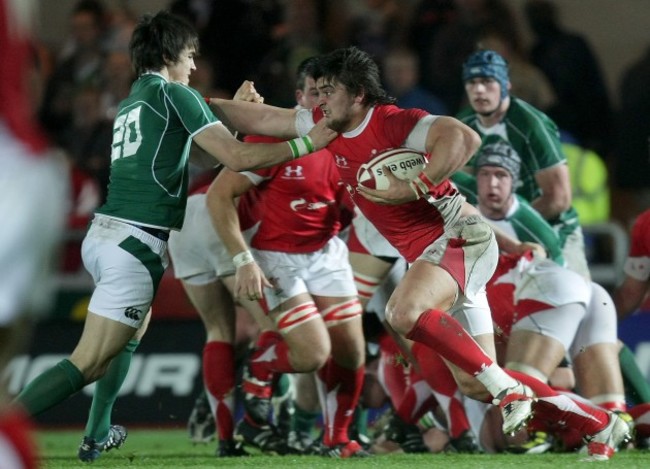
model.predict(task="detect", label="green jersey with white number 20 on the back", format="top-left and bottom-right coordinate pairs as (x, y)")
top-left (97, 73), bottom-right (219, 229)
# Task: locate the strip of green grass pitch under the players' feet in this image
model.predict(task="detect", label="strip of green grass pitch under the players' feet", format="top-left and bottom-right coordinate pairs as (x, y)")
top-left (37, 429), bottom-right (650, 469)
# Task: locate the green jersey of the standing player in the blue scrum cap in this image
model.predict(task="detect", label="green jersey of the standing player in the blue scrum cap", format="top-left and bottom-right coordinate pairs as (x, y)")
top-left (458, 96), bottom-right (579, 245)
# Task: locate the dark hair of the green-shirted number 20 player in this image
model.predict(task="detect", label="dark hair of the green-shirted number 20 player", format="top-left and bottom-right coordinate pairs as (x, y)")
top-left (129, 11), bottom-right (199, 76)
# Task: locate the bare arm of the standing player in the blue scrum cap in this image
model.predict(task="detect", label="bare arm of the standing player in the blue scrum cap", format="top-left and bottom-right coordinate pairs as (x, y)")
top-left (531, 164), bottom-right (571, 220)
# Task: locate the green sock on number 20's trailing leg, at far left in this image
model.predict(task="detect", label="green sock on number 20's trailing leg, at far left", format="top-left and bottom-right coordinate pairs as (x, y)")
top-left (16, 359), bottom-right (86, 415)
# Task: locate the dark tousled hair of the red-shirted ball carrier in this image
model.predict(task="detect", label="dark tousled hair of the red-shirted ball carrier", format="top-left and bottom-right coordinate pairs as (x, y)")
top-left (314, 47), bottom-right (397, 106)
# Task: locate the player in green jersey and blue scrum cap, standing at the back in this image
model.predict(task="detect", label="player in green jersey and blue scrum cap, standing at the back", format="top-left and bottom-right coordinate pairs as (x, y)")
top-left (457, 50), bottom-right (590, 278)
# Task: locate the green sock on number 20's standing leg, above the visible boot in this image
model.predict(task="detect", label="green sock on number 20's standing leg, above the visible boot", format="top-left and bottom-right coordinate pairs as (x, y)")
top-left (85, 340), bottom-right (140, 441)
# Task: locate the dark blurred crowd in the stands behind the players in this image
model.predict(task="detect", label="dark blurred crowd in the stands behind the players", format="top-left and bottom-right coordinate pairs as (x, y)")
top-left (38, 0), bottom-right (650, 270)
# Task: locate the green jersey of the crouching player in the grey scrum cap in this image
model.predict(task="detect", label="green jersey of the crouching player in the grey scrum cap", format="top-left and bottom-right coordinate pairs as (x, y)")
top-left (451, 171), bottom-right (565, 266)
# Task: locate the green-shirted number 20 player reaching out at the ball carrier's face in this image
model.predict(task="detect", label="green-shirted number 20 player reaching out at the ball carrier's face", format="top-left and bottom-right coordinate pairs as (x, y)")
top-left (17, 11), bottom-right (336, 461)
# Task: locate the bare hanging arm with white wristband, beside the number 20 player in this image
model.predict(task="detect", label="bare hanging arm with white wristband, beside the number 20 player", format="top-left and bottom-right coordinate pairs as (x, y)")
top-left (206, 169), bottom-right (271, 300)
